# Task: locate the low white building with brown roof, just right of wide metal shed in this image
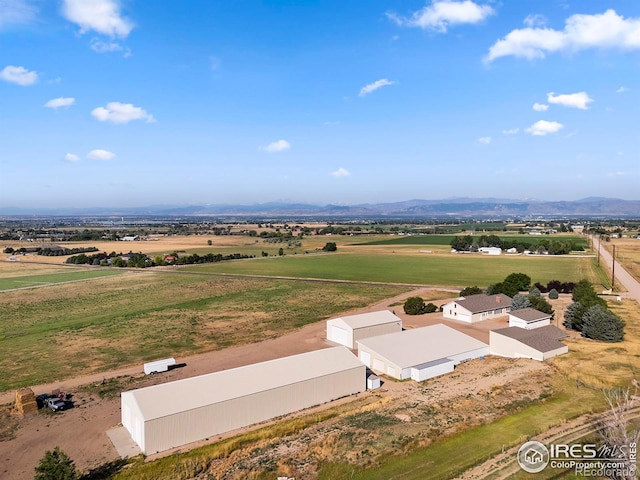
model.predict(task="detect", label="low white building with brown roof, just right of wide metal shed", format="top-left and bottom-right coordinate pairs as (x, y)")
top-left (489, 325), bottom-right (569, 361)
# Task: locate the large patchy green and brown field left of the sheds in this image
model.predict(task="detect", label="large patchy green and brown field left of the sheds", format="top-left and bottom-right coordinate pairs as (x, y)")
top-left (0, 271), bottom-right (406, 391)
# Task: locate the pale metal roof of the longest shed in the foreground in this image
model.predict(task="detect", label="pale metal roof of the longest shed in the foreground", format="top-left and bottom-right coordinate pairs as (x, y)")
top-left (122, 347), bottom-right (365, 420)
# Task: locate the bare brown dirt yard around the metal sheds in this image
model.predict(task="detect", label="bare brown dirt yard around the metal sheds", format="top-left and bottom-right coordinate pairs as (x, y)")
top-left (0, 289), bottom-right (548, 479)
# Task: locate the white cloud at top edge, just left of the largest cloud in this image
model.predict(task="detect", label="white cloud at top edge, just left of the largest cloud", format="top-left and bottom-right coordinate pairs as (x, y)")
top-left (387, 0), bottom-right (495, 33)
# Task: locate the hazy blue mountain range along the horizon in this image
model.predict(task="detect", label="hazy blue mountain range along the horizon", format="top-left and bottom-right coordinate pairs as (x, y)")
top-left (0, 197), bottom-right (640, 218)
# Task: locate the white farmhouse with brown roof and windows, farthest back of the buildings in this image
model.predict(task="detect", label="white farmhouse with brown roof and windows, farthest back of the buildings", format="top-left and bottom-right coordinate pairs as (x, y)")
top-left (442, 293), bottom-right (511, 323)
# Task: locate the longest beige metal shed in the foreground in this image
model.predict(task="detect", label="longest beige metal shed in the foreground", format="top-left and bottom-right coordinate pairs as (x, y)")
top-left (121, 347), bottom-right (366, 455)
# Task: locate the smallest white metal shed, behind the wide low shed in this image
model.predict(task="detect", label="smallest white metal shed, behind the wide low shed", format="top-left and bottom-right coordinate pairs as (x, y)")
top-left (327, 310), bottom-right (402, 349)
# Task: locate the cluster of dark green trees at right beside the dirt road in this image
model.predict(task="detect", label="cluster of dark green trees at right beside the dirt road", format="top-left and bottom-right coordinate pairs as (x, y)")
top-left (563, 280), bottom-right (624, 342)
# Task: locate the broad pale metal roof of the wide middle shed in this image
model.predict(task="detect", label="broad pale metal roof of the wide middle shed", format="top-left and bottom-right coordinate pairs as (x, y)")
top-left (357, 323), bottom-right (489, 368)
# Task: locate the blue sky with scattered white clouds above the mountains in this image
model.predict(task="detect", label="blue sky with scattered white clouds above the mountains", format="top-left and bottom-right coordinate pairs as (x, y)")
top-left (0, 0), bottom-right (640, 208)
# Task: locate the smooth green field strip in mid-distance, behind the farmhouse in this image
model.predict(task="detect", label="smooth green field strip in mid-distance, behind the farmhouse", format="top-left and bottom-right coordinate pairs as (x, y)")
top-left (184, 253), bottom-right (597, 287)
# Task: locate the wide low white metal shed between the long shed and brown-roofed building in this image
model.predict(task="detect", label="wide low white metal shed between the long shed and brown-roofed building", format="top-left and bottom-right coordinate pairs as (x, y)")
top-left (358, 323), bottom-right (489, 382)
